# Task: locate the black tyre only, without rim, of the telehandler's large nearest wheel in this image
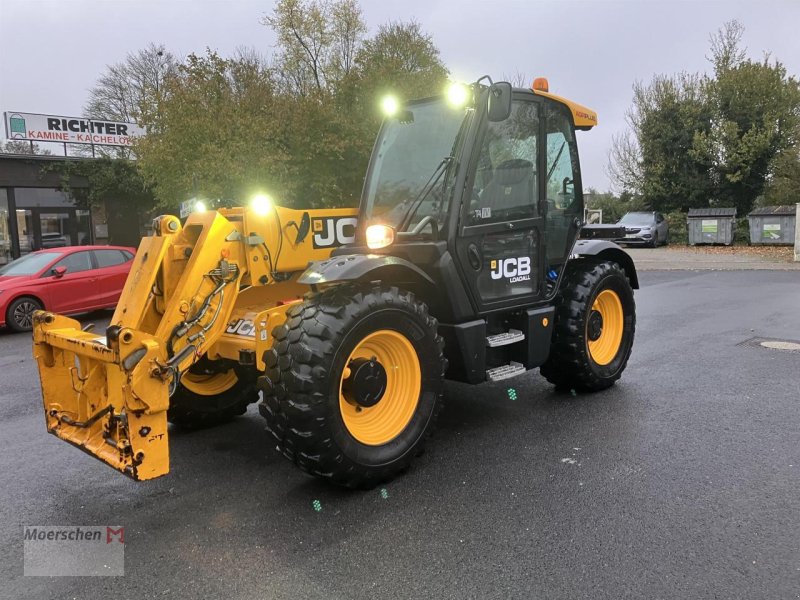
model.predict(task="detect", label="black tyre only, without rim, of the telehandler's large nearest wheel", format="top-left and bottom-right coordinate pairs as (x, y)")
top-left (259, 284), bottom-right (447, 488)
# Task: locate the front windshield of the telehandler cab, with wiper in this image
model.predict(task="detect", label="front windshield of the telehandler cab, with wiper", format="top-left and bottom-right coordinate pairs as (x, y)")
top-left (366, 99), bottom-right (469, 228)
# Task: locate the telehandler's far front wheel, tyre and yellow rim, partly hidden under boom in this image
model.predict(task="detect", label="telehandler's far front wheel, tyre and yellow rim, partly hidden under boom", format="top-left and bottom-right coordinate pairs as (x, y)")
top-left (167, 359), bottom-right (258, 429)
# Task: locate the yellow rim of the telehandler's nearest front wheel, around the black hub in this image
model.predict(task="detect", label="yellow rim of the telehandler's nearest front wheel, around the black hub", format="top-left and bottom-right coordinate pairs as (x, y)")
top-left (339, 329), bottom-right (422, 446)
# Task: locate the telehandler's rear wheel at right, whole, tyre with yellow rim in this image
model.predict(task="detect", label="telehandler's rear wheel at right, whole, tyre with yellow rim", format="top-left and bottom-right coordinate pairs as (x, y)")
top-left (540, 260), bottom-right (636, 391)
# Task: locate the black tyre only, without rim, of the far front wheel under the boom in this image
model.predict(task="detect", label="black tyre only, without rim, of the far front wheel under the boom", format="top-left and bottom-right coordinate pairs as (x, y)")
top-left (167, 369), bottom-right (258, 429)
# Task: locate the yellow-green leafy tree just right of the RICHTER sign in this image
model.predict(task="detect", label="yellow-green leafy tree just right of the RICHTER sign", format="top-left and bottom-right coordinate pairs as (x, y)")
top-left (135, 50), bottom-right (297, 208)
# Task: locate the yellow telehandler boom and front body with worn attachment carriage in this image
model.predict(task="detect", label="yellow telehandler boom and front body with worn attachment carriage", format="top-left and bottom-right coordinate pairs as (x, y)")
top-left (33, 207), bottom-right (357, 480)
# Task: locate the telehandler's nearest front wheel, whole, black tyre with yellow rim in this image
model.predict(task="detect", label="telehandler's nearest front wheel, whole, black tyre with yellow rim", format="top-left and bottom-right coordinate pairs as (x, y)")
top-left (259, 284), bottom-right (446, 488)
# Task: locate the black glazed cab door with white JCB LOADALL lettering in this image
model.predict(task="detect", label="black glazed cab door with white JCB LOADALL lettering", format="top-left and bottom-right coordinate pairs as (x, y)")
top-left (456, 93), bottom-right (544, 312)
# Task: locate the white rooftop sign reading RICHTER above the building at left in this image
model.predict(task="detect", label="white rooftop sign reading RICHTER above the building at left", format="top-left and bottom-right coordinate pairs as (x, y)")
top-left (5, 112), bottom-right (146, 146)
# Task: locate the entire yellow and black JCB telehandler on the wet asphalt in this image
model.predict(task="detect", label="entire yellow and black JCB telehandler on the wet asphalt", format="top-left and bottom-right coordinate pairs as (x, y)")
top-left (34, 78), bottom-right (638, 487)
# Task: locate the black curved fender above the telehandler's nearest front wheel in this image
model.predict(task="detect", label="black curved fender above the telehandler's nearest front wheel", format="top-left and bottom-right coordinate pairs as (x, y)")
top-left (297, 254), bottom-right (435, 286)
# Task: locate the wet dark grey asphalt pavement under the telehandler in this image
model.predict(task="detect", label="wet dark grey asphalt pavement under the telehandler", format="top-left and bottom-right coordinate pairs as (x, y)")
top-left (0, 271), bottom-right (800, 600)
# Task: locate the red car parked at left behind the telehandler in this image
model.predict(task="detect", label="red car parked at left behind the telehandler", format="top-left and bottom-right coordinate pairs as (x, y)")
top-left (0, 246), bottom-right (136, 331)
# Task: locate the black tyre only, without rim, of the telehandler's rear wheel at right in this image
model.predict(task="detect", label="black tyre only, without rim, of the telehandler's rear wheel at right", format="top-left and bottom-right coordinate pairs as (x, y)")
top-left (540, 260), bottom-right (636, 391)
